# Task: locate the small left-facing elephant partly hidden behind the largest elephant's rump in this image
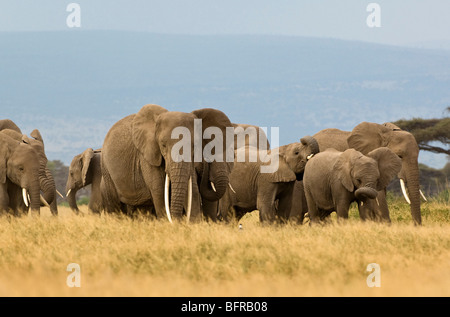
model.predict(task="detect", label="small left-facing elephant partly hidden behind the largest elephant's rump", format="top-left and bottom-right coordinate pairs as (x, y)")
top-left (66, 148), bottom-right (103, 214)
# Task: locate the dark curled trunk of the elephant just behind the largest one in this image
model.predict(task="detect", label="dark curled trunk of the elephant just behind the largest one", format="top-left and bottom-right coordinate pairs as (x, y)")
top-left (200, 162), bottom-right (230, 201)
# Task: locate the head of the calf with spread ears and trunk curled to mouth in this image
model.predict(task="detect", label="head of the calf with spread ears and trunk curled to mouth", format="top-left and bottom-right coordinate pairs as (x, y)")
top-left (333, 147), bottom-right (401, 201)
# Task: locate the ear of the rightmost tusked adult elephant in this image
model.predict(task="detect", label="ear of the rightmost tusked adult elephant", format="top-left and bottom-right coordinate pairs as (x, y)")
top-left (347, 122), bottom-right (390, 154)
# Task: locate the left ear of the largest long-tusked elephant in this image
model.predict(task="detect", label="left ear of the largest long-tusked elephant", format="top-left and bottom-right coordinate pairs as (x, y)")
top-left (131, 105), bottom-right (167, 166)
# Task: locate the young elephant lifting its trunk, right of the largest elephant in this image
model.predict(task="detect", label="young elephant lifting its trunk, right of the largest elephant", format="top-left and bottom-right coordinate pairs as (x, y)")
top-left (220, 136), bottom-right (319, 222)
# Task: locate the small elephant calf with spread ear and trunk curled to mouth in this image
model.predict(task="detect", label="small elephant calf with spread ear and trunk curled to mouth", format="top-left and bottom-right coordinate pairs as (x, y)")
top-left (303, 147), bottom-right (402, 223)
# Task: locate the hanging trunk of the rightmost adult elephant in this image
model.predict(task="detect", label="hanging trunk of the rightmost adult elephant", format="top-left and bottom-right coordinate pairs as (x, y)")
top-left (402, 162), bottom-right (422, 225)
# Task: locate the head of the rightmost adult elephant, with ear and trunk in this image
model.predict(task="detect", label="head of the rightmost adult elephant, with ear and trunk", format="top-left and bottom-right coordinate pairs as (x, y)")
top-left (347, 122), bottom-right (422, 225)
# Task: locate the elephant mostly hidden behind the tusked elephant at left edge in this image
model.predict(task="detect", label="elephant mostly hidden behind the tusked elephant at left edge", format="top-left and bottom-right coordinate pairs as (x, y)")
top-left (1, 127), bottom-right (58, 215)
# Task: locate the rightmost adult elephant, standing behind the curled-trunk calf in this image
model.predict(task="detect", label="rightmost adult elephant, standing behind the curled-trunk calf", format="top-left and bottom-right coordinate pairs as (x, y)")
top-left (291, 122), bottom-right (422, 225)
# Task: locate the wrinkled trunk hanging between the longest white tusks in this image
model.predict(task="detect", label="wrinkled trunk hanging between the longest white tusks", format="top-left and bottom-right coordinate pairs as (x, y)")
top-left (169, 162), bottom-right (191, 219)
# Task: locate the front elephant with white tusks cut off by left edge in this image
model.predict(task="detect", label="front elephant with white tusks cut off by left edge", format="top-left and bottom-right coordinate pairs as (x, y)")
top-left (0, 133), bottom-right (41, 215)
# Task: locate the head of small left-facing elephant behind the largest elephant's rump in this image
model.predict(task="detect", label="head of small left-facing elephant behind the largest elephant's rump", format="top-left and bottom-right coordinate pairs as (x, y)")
top-left (66, 148), bottom-right (95, 214)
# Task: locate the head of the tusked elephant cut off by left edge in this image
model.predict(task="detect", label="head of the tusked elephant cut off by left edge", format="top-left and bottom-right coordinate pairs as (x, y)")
top-left (0, 133), bottom-right (41, 212)
